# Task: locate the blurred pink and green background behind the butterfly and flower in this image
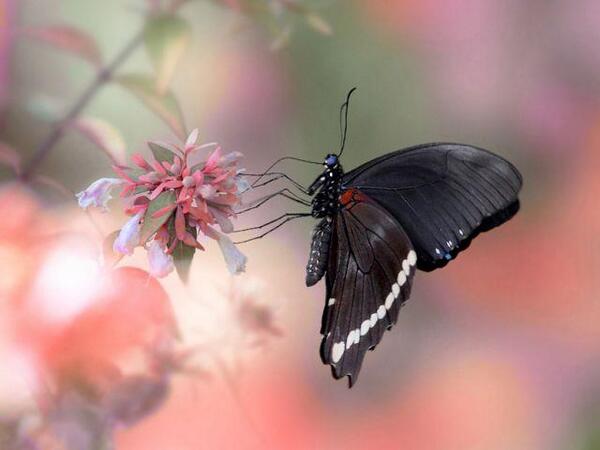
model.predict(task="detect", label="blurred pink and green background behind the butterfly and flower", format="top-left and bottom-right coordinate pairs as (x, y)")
top-left (0, 0), bottom-right (600, 450)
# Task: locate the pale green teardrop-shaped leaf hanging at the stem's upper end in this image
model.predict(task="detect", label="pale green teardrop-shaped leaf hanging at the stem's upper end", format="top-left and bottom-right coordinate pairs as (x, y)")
top-left (144, 14), bottom-right (192, 94)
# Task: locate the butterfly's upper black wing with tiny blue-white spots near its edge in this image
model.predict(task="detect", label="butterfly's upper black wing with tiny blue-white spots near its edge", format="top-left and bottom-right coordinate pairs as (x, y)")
top-left (343, 144), bottom-right (522, 270)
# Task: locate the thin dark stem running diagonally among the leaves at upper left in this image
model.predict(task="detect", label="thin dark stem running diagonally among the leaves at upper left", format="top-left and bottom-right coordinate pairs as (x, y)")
top-left (20, 31), bottom-right (143, 182)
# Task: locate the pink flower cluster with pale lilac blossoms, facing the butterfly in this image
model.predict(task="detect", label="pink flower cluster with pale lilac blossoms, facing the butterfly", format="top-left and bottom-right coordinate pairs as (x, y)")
top-left (77, 130), bottom-right (249, 278)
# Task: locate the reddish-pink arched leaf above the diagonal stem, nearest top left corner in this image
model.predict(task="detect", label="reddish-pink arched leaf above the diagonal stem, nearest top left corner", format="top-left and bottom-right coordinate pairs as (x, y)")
top-left (24, 25), bottom-right (102, 67)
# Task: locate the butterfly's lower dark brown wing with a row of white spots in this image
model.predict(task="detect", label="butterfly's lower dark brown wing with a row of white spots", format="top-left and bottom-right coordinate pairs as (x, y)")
top-left (321, 190), bottom-right (417, 386)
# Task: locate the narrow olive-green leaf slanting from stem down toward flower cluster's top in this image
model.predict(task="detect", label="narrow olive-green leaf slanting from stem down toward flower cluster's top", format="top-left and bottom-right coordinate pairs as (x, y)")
top-left (116, 74), bottom-right (186, 140)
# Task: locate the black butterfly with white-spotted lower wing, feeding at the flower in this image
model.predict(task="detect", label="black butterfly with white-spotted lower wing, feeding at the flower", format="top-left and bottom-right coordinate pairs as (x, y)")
top-left (306, 91), bottom-right (523, 386)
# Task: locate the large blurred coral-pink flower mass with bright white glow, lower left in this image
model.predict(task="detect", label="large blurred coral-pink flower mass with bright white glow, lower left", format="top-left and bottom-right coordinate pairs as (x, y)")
top-left (0, 185), bottom-right (180, 450)
